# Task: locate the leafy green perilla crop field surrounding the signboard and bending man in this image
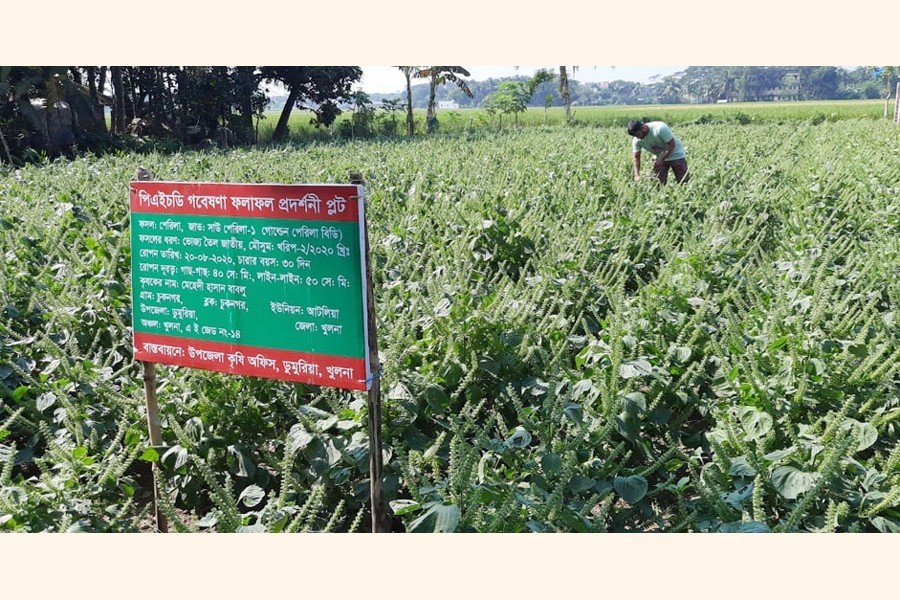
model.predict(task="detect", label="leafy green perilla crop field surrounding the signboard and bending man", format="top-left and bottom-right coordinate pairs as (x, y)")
top-left (0, 115), bottom-right (900, 532)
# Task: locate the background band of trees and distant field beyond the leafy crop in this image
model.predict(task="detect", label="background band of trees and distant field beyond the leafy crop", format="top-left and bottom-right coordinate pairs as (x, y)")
top-left (0, 66), bottom-right (898, 164)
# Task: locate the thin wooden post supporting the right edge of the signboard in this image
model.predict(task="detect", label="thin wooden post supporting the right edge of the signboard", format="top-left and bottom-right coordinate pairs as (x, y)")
top-left (350, 173), bottom-right (391, 533)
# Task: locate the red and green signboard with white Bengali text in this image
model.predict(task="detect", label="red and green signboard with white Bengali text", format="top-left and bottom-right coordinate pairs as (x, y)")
top-left (130, 181), bottom-right (372, 390)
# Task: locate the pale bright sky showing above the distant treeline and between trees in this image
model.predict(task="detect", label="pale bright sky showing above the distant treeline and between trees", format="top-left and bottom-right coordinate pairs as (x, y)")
top-left (361, 65), bottom-right (687, 94)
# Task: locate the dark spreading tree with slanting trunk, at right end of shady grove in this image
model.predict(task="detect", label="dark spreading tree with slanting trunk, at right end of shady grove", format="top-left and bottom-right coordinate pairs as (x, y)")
top-left (261, 67), bottom-right (362, 141)
